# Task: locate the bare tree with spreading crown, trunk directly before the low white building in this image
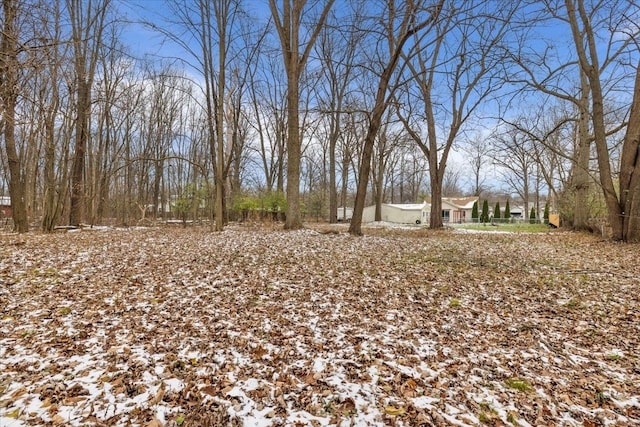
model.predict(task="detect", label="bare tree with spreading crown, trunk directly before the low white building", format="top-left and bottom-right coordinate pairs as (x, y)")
top-left (399, 1), bottom-right (518, 228)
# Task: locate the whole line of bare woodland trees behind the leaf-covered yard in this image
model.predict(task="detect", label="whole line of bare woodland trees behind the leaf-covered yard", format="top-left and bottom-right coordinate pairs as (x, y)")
top-left (0, 0), bottom-right (640, 241)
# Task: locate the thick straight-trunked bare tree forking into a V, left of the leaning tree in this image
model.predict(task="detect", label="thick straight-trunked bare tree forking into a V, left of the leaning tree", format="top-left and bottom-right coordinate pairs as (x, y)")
top-left (269, 0), bottom-right (335, 230)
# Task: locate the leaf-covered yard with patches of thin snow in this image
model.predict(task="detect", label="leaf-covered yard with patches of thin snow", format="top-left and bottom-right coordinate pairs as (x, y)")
top-left (0, 226), bottom-right (640, 427)
